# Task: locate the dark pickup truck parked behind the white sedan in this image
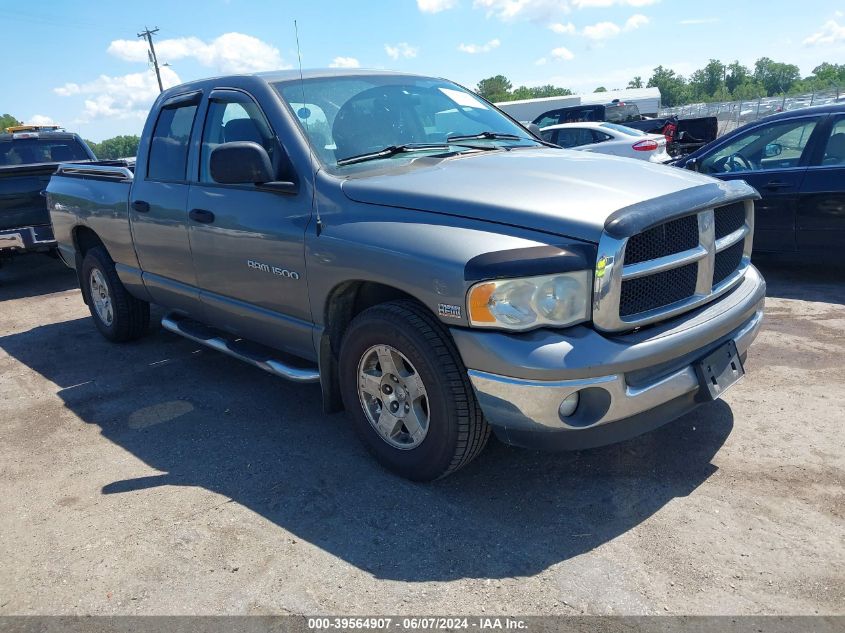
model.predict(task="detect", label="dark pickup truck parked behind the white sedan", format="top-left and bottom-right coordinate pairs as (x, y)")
top-left (533, 102), bottom-right (719, 156)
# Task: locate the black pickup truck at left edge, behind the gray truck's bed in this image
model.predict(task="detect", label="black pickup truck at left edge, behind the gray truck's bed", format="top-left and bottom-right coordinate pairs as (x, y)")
top-left (0, 126), bottom-right (95, 263)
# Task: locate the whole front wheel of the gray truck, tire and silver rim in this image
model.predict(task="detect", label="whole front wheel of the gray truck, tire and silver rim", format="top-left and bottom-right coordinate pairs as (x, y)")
top-left (340, 301), bottom-right (490, 481)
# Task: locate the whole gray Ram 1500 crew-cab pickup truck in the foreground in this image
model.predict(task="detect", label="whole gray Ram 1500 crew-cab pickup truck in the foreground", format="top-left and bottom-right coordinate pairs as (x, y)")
top-left (47, 70), bottom-right (765, 480)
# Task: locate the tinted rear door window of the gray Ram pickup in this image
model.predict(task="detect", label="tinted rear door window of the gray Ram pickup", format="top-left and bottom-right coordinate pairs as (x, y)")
top-left (147, 102), bottom-right (197, 182)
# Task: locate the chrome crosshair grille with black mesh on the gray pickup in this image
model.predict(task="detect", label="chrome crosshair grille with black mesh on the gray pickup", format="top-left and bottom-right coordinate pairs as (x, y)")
top-left (593, 200), bottom-right (754, 332)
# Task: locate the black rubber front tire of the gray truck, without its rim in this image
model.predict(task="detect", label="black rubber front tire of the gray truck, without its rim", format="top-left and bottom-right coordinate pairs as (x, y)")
top-left (339, 301), bottom-right (490, 481)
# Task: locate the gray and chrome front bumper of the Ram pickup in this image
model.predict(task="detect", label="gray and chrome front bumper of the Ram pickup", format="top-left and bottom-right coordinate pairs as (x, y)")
top-left (452, 266), bottom-right (766, 450)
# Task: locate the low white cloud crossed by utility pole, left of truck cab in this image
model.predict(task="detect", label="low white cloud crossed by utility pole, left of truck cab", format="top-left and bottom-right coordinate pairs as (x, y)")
top-left (53, 66), bottom-right (181, 121)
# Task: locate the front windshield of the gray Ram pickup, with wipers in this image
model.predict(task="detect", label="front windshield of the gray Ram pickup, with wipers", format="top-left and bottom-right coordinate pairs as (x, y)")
top-left (274, 75), bottom-right (538, 169)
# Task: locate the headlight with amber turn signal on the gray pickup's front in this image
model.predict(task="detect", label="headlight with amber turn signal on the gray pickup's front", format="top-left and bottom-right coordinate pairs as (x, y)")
top-left (467, 270), bottom-right (593, 330)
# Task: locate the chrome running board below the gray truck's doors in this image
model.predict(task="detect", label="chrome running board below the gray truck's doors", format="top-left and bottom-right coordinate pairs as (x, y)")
top-left (161, 313), bottom-right (320, 382)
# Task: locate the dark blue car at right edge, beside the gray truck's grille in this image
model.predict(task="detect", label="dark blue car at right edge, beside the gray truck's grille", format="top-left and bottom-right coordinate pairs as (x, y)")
top-left (676, 104), bottom-right (845, 259)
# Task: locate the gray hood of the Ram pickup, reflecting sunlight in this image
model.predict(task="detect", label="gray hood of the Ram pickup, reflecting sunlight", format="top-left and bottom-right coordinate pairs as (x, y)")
top-left (342, 148), bottom-right (714, 242)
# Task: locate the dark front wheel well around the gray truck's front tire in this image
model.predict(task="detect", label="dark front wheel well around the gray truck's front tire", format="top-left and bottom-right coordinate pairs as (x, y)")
top-left (319, 281), bottom-right (428, 413)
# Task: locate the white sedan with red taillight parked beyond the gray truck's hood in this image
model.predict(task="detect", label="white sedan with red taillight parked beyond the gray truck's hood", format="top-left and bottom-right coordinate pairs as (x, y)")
top-left (540, 123), bottom-right (672, 163)
